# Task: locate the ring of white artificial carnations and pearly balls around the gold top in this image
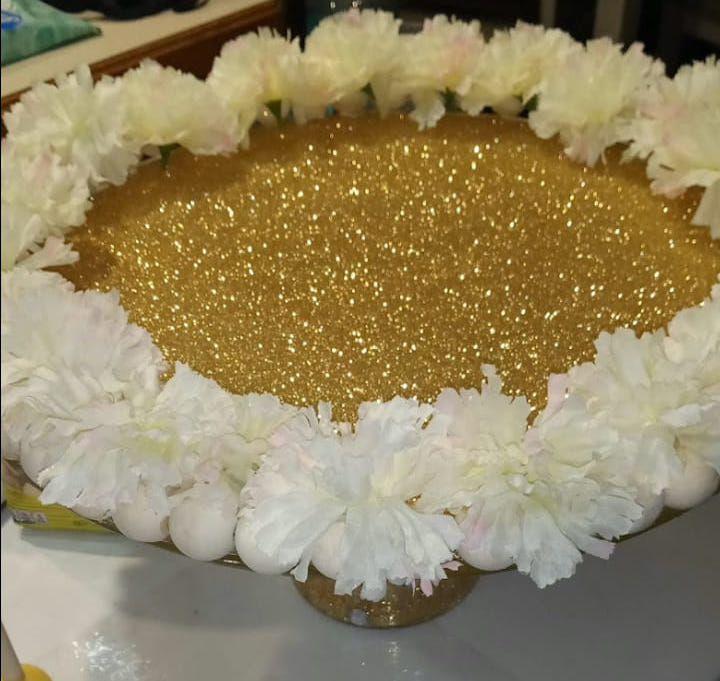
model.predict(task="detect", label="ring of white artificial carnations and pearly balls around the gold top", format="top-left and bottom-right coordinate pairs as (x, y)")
top-left (2, 11), bottom-right (720, 599)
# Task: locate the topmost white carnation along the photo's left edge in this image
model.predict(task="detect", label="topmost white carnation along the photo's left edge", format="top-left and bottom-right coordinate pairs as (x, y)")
top-left (3, 66), bottom-right (138, 186)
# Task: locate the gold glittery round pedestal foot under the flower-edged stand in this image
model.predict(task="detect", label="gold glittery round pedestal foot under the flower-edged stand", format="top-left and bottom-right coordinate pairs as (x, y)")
top-left (295, 566), bottom-right (478, 629)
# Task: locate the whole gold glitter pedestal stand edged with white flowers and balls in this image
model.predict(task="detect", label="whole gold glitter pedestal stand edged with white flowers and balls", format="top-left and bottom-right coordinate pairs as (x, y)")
top-left (2, 11), bottom-right (720, 626)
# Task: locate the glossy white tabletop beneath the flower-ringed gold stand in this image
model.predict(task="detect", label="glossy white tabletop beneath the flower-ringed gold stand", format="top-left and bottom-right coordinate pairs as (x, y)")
top-left (1, 496), bottom-right (720, 681)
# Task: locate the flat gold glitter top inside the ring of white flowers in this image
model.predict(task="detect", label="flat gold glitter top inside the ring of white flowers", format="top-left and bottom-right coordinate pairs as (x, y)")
top-left (62, 115), bottom-right (720, 420)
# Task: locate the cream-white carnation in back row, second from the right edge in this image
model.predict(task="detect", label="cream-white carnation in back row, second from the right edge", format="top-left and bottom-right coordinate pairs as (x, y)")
top-left (530, 38), bottom-right (662, 166)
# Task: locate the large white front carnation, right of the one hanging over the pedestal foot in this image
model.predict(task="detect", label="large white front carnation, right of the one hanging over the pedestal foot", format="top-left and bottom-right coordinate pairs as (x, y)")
top-left (419, 366), bottom-right (640, 587)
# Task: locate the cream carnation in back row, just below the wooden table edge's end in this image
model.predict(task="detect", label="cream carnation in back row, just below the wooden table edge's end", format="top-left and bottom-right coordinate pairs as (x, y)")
top-left (207, 28), bottom-right (300, 133)
